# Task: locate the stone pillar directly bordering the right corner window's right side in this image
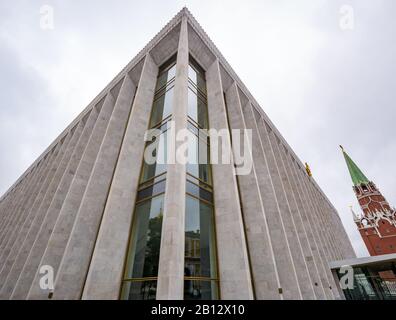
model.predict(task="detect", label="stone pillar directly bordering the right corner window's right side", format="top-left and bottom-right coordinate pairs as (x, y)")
top-left (206, 59), bottom-right (254, 299)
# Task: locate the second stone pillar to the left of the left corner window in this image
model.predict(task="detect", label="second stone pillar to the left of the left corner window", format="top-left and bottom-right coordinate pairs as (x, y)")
top-left (54, 74), bottom-right (136, 299)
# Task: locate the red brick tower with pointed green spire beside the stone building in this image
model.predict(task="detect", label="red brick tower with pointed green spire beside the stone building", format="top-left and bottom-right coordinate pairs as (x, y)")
top-left (341, 146), bottom-right (396, 256)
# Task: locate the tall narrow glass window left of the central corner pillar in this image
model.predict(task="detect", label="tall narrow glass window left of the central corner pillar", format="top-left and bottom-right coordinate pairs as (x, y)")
top-left (121, 58), bottom-right (175, 300)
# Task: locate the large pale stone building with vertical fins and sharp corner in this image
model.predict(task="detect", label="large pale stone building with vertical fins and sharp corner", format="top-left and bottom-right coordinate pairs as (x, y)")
top-left (0, 8), bottom-right (355, 299)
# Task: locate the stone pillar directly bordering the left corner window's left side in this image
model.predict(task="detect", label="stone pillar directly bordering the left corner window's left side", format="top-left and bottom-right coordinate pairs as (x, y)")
top-left (82, 54), bottom-right (158, 299)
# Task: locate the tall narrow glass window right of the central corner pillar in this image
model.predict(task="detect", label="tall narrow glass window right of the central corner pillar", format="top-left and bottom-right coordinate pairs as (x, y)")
top-left (184, 57), bottom-right (219, 300)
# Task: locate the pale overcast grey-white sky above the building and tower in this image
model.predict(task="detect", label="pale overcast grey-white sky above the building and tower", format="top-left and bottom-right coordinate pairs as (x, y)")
top-left (0, 0), bottom-right (396, 256)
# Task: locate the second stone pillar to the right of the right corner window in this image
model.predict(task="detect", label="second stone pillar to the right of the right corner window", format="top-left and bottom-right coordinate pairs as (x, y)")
top-left (226, 83), bottom-right (282, 300)
